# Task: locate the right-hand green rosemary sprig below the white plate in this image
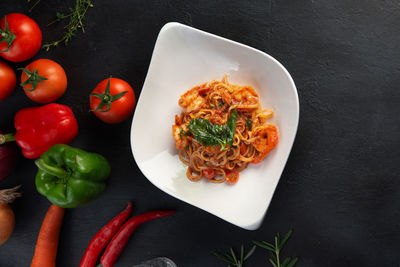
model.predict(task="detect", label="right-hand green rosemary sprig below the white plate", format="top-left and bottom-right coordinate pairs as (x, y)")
top-left (253, 230), bottom-right (299, 267)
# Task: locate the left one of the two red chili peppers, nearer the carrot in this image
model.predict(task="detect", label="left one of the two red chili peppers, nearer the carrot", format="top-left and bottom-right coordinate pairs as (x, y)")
top-left (79, 202), bottom-right (132, 267)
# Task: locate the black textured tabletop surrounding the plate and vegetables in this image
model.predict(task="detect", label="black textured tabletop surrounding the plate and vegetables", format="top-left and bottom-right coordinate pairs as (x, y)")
top-left (0, 0), bottom-right (400, 267)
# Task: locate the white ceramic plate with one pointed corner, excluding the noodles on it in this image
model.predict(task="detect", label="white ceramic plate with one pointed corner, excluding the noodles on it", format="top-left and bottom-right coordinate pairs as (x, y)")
top-left (131, 23), bottom-right (299, 230)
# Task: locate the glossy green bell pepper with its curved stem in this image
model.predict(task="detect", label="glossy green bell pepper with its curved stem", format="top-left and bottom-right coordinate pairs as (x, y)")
top-left (35, 144), bottom-right (111, 208)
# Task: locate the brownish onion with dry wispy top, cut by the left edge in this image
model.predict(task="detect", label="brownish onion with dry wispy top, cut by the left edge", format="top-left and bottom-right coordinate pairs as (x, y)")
top-left (0, 185), bottom-right (21, 246)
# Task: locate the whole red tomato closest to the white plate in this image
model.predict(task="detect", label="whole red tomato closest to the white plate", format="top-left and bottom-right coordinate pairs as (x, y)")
top-left (90, 78), bottom-right (136, 123)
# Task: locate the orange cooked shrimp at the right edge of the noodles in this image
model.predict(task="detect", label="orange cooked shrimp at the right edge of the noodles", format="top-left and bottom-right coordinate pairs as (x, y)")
top-left (252, 124), bottom-right (278, 164)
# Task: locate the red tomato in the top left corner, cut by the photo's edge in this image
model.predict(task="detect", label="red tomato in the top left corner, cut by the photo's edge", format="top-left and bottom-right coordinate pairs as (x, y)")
top-left (0, 13), bottom-right (42, 62)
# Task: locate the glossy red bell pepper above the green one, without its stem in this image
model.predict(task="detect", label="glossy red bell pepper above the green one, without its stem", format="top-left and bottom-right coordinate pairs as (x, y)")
top-left (15, 103), bottom-right (78, 159)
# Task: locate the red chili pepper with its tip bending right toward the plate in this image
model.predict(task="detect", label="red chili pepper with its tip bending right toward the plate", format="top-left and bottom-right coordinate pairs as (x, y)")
top-left (100, 210), bottom-right (175, 267)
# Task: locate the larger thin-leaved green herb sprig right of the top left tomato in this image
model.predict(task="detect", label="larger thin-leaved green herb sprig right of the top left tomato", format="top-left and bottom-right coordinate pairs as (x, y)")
top-left (42, 0), bottom-right (94, 51)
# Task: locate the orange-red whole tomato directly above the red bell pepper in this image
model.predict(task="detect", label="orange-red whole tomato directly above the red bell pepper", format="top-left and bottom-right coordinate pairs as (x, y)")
top-left (21, 59), bottom-right (67, 104)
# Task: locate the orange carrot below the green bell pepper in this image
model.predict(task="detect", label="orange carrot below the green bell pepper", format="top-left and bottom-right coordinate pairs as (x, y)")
top-left (31, 204), bottom-right (64, 267)
